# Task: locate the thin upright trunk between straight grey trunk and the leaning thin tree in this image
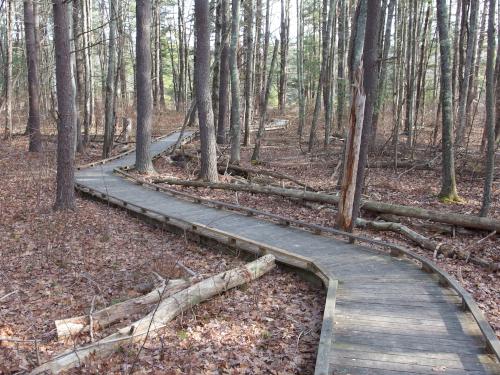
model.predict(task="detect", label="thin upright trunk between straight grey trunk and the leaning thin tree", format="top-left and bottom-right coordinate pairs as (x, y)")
top-left (243, 0), bottom-right (255, 146)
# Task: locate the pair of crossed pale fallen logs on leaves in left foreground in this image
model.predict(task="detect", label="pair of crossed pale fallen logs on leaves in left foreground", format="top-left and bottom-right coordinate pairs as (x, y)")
top-left (31, 255), bottom-right (275, 374)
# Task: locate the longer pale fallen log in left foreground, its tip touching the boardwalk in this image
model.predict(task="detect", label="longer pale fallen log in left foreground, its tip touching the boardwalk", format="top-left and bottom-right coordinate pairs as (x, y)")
top-left (31, 255), bottom-right (275, 374)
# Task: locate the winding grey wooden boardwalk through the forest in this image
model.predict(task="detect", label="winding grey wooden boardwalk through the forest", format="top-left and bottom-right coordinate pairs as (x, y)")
top-left (76, 134), bottom-right (500, 375)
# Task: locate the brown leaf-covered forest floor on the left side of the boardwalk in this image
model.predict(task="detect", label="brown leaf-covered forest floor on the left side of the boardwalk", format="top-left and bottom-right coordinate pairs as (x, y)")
top-left (0, 129), bottom-right (325, 374)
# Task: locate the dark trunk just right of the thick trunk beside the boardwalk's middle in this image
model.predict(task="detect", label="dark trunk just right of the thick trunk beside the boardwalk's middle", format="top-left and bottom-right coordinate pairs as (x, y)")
top-left (217, 0), bottom-right (229, 145)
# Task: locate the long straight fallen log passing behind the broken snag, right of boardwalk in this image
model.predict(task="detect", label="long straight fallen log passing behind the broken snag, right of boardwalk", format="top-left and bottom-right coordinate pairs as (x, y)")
top-left (153, 178), bottom-right (500, 232)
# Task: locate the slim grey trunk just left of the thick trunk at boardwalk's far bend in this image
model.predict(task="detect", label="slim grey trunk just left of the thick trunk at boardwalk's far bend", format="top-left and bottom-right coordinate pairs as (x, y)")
top-left (102, 0), bottom-right (118, 159)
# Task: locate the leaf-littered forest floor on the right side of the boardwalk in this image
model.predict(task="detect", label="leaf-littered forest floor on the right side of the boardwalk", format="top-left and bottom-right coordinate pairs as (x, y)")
top-left (143, 114), bottom-right (500, 337)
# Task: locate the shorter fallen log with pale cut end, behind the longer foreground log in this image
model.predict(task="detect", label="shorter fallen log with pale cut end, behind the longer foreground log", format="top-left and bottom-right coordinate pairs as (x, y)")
top-left (55, 279), bottom-right (191, 340)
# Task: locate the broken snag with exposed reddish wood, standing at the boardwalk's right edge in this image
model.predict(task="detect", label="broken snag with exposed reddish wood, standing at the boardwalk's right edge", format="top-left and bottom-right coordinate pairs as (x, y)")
top-left (337, 62), bottom-right (366, 232)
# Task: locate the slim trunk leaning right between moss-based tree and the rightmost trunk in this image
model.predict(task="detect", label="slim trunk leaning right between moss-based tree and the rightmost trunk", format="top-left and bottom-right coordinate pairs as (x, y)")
top-left (455, 0), bottom-right (479, 145)
